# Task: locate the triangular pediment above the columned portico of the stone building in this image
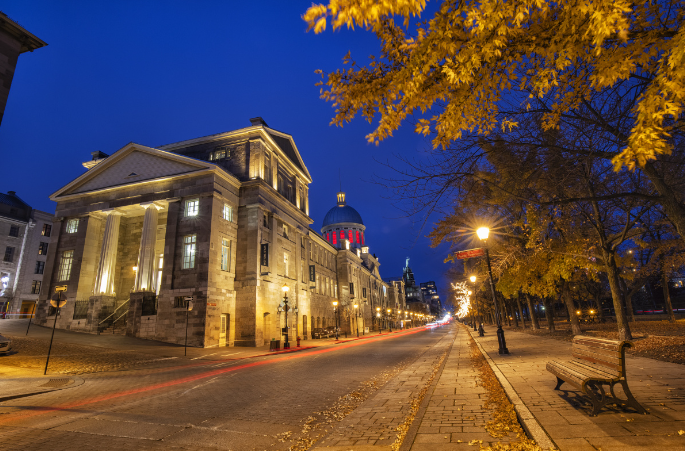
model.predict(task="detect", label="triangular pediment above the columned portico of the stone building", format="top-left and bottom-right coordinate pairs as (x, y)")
top-left (50, 144), bottom-right (214, 200)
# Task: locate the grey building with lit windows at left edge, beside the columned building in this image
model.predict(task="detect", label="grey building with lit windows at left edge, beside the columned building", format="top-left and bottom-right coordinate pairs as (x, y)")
top-left (0, 191), bottom-right (52, 318)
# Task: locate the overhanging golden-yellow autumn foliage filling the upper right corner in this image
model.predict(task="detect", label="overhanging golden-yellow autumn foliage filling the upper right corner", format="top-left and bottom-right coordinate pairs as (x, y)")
top-left (304, 0), bottom-right (685, 240)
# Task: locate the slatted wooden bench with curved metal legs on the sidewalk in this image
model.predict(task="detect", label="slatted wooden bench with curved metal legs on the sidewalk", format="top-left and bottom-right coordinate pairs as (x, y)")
top-left (547, 335), bottom-right (647, 417)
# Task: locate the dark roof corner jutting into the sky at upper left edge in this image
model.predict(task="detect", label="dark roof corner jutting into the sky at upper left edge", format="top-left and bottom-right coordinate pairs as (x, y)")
top-left (0, 11), bottom-right (47, 124)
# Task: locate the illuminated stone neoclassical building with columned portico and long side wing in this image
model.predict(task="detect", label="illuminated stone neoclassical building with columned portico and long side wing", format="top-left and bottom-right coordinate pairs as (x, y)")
top-left (37, 118), bottom-right (404, 347)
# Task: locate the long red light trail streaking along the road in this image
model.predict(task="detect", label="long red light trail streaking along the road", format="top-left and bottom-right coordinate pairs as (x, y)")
top-left (0, 328), bottom-right (444, 425)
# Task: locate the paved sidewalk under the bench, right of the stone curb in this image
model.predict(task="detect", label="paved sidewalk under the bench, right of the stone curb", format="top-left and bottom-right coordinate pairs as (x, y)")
top-left (474, 327), bottom-right (685, 451)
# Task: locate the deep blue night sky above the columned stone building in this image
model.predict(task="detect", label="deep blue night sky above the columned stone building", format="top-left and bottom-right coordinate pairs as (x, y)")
top-left (0, 0), bottom-right (448, 300)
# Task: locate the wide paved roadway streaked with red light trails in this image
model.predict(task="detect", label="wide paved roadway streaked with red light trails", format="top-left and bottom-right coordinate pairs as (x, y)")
top-left (0, 326), bottom-right (451, 451)
